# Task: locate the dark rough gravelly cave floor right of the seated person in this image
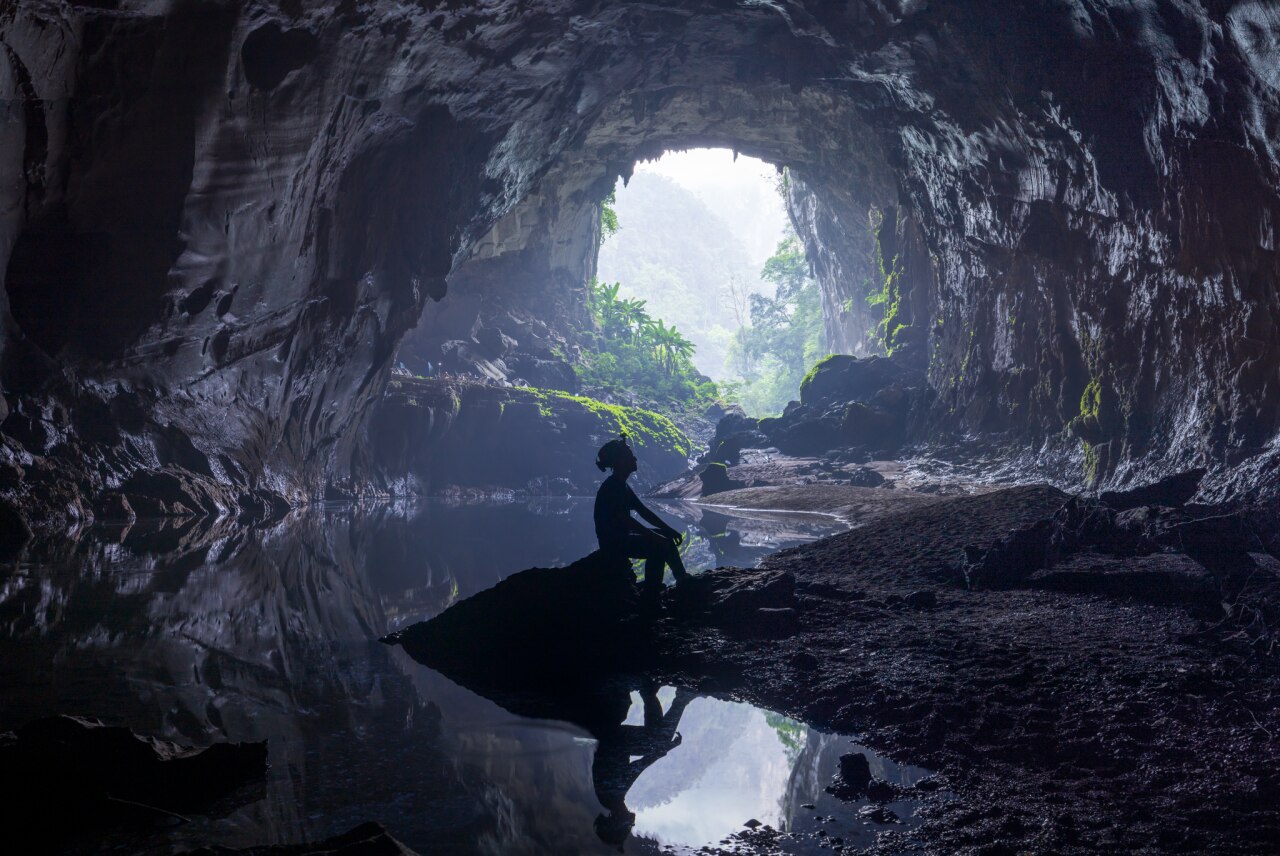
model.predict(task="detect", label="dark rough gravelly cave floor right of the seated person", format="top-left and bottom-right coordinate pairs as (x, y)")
top-left (645, 486), bottom-right (1280, 853)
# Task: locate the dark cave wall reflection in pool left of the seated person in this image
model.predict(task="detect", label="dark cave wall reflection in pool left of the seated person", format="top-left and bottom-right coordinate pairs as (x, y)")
top-left (0, 507), bottom-right (619, 853)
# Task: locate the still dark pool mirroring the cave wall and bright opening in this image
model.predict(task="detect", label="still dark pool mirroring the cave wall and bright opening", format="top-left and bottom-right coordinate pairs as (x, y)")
top-left (0, 499), bottom-right (924, 853)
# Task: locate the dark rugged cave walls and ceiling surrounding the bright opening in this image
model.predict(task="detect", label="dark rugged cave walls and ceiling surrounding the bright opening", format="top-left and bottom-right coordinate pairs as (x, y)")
top-left (0, 0), bottom-right (1280, 522)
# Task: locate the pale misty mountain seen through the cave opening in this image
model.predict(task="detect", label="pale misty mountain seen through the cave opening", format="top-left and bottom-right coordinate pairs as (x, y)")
top-left (596, 171), bottom-right (781, 380)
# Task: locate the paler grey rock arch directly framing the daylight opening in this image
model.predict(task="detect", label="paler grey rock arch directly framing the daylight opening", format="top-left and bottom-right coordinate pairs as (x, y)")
top-left (397, 69), bottom-right (897, 414)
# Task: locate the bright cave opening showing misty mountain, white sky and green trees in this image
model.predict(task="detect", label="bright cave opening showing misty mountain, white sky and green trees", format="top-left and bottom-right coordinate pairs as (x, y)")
top-left (590, 148), bottom-right (827, 416)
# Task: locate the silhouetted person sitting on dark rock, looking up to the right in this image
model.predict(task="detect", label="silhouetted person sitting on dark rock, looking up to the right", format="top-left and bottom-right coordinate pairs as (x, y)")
top-left (595, 434), bottom-right (689, 603)
